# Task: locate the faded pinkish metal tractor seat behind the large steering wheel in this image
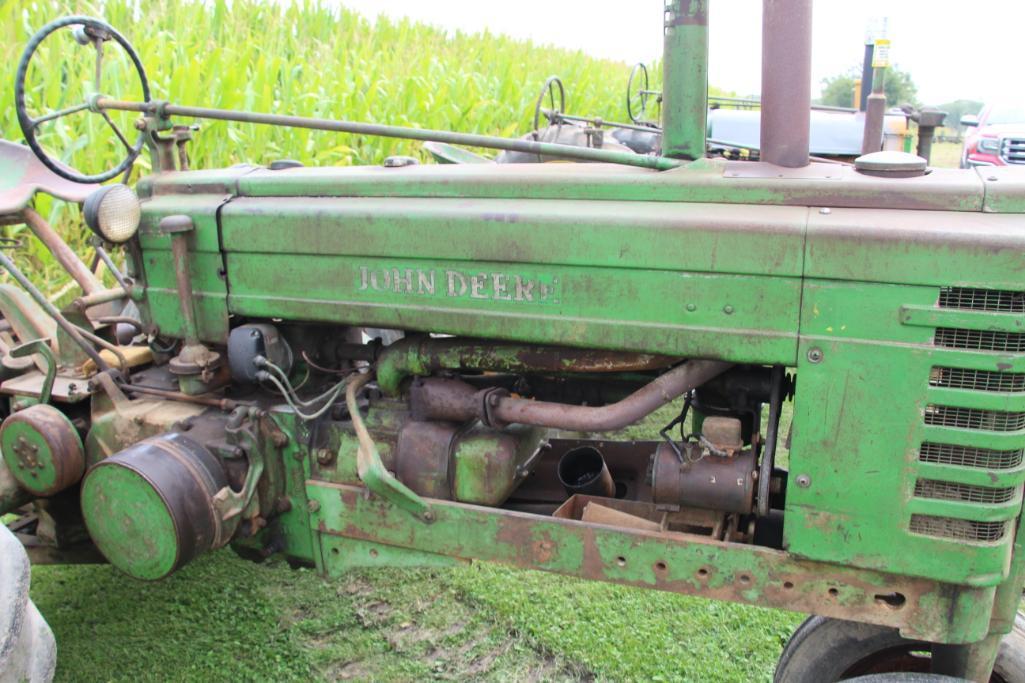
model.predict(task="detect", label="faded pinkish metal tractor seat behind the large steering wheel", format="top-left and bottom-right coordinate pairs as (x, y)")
top-left (0, 139), bottom-right (99, 215)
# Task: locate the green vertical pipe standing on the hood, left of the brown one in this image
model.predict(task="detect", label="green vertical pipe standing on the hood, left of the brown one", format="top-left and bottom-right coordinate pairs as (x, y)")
top-left (662, 0), bottom-right (709, 159)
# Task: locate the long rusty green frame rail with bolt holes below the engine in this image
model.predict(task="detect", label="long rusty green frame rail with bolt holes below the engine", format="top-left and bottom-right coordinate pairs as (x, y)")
top-left (306, 481), bottom-right (992, 642)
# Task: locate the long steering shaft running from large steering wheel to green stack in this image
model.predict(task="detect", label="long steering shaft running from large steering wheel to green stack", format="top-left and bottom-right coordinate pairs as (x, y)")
top-left (96, 97), bottom-right (682, 170)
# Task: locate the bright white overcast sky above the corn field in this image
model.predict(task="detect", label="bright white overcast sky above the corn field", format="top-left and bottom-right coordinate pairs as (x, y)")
top-left (334, 0), bottom-right (1025, 105)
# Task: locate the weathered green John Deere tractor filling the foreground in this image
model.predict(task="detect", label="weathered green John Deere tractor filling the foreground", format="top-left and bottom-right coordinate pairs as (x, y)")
top-left (0, 0), bottom-right (1025, 683)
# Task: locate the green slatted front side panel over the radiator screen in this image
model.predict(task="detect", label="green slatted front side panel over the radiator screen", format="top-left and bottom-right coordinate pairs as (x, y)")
top-left (784, 281), bottom-right (1025, 587)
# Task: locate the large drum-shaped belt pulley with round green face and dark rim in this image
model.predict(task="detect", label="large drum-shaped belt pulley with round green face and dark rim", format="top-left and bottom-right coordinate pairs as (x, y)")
top-left (82, 433), bottom-right (228, 579)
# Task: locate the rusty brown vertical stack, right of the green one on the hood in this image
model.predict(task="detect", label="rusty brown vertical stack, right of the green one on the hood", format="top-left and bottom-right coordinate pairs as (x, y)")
top-left (761, 0), bottom-right (812, 168)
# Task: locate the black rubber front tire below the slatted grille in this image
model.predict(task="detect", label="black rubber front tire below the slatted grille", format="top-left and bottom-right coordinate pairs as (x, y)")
top-left (773, 614), bottom-right (1025, 683)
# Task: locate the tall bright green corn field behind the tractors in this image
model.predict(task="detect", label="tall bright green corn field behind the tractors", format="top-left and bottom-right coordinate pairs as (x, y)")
top-left (0, 0), bottom-right (733, 291)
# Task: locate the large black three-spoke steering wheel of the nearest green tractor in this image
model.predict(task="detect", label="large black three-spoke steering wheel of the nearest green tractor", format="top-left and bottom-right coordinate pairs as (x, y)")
top-left (14, 16), bottom-right (150, 183)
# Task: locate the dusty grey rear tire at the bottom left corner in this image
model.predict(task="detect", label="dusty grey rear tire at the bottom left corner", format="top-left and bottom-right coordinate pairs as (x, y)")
top-left (0, 524), bottom-right (57, 683)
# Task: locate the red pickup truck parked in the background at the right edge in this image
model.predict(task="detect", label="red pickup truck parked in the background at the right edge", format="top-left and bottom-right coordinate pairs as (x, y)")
top-left (960, 105), bottom-right (1025, 168)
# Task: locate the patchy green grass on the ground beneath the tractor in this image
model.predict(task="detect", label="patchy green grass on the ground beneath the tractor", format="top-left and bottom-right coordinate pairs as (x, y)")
top-left (32, 550), bottom-right (801, 683)
